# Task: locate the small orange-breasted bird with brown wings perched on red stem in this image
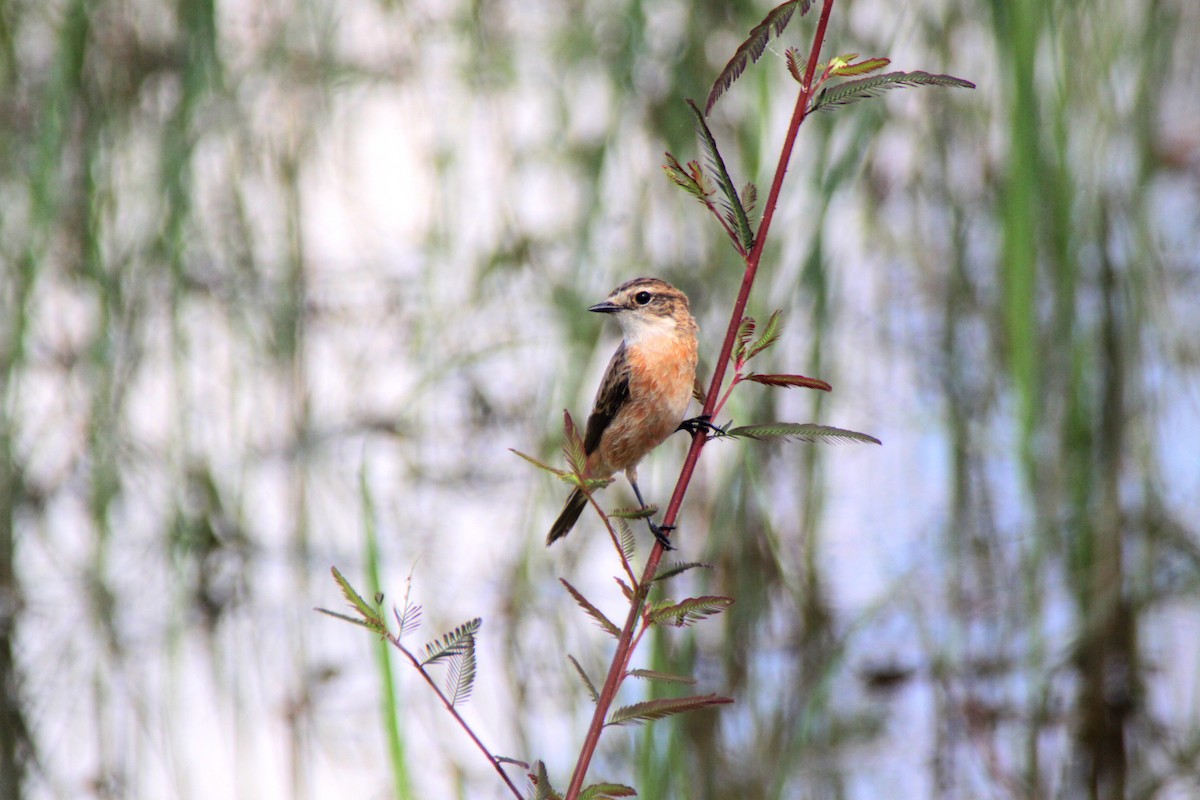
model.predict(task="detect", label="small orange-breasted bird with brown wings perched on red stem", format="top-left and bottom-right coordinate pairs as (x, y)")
top-left (546, 278), bottom-right (698, 545)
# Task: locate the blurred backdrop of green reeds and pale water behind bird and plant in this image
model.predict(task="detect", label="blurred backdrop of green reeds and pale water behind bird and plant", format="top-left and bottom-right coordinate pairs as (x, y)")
top-left (0, 0), bottom-right (1200, 799)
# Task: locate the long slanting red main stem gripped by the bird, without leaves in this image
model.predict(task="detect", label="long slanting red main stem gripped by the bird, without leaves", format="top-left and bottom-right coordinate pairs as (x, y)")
top-left (564, 0), bottom-right (834, 800)
